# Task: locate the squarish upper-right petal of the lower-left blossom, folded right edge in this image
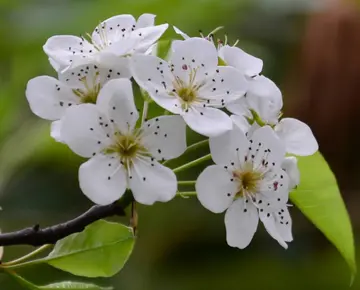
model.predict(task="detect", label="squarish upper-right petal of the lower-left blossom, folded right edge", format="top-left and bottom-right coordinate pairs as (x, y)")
top-left (142, 116), bottom-right (187, 160)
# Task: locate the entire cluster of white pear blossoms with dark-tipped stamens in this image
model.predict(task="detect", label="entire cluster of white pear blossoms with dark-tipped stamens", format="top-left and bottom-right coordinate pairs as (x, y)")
top-left (26, 14), bottom-right (318, 248)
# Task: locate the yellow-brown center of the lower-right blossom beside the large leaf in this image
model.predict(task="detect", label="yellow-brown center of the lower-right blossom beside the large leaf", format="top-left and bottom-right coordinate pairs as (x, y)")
top-left (233, 170), bottom-right (262, 197)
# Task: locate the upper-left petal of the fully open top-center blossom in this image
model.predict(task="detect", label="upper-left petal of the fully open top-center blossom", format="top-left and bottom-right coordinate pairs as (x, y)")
top-left (131, 55), bottom-right (182, 114)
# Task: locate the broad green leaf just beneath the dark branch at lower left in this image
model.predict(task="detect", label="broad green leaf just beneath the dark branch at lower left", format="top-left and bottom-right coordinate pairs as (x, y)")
top-left (42, 220), bottom-right (135, 277)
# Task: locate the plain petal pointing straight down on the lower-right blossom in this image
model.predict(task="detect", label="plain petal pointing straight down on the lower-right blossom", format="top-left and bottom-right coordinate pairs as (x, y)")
top-left (225, 198), bottom-right (259, 249)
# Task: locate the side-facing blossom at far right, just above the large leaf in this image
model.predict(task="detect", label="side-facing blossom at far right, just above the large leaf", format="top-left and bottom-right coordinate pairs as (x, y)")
top-left (226, 76), bottom-right (319, 156)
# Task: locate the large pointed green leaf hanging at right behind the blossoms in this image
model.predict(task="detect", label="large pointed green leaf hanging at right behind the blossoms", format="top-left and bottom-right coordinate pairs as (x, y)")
top-left (290, 152), bottom-right (356, 277)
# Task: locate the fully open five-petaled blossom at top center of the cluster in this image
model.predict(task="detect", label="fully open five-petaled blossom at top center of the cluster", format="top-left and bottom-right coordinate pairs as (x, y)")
top-left (131, 38), bottom-right (247, 136)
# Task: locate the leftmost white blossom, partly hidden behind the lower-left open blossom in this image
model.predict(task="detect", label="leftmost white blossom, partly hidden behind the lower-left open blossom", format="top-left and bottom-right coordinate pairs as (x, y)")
top-left (25, 62), bottom-right (125, 141)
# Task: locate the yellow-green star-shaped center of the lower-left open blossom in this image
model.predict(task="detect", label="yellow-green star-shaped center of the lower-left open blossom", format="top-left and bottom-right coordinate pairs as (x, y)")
top-left (105, 133), bottom-right (149, 168)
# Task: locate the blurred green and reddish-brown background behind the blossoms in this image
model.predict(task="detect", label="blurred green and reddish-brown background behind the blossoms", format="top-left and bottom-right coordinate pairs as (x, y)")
top-left (0, 0), bottom-right (360, 290)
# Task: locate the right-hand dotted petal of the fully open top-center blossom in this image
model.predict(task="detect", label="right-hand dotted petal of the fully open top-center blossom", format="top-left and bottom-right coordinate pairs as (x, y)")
top-left (198, 66), bottom-right (248, 107)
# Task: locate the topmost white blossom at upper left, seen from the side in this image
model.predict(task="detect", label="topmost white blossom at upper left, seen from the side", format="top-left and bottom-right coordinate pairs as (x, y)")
top-left (44, 14), bottom-right (168, 71)
